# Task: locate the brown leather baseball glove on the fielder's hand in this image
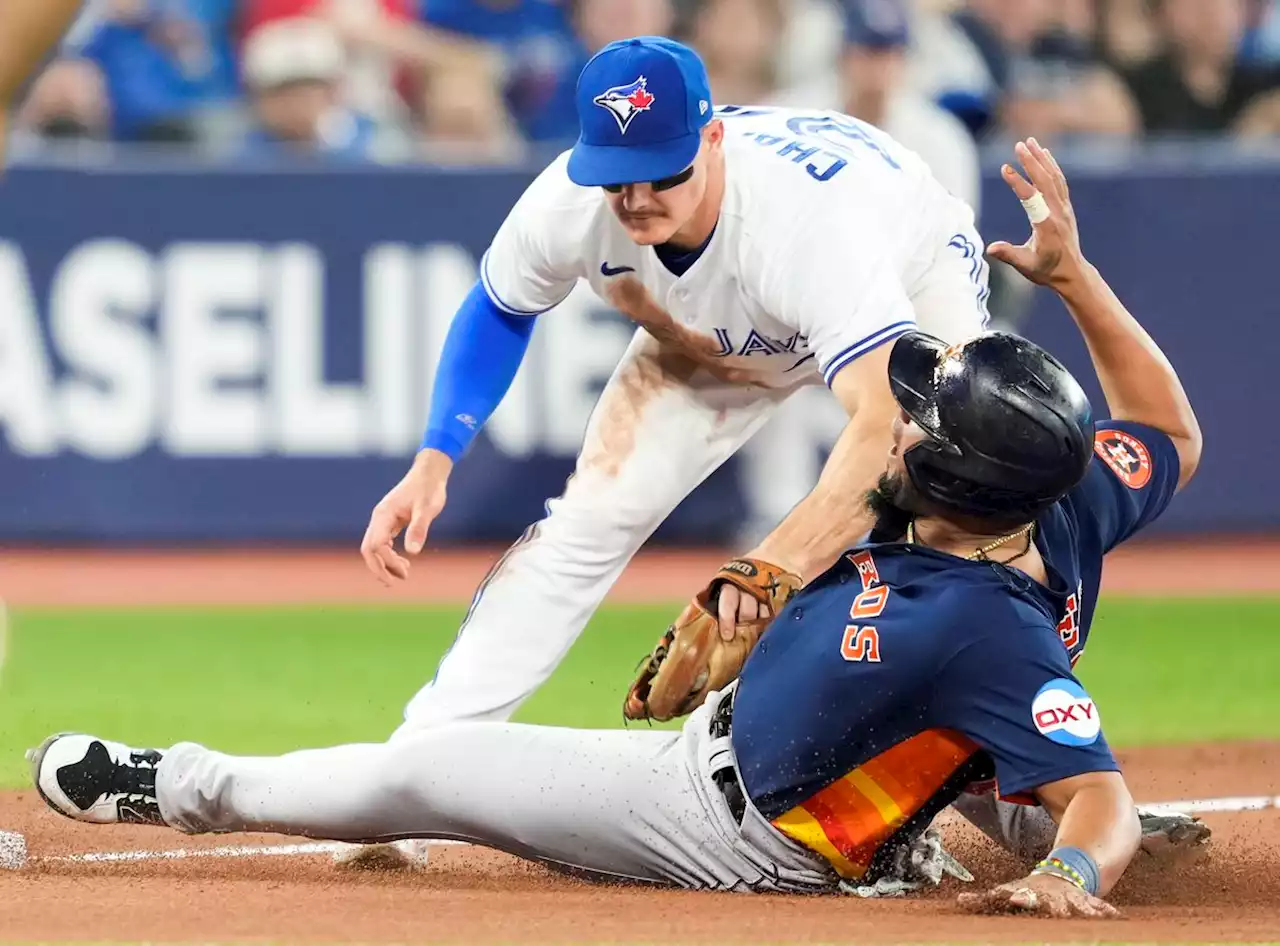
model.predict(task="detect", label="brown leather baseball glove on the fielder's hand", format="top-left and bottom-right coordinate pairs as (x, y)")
top-left (622, 558), bottom-right (801, 722)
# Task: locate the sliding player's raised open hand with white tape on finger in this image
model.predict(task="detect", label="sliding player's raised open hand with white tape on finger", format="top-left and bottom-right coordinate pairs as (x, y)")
top-left (987, 138), bottom-right (1088, 287)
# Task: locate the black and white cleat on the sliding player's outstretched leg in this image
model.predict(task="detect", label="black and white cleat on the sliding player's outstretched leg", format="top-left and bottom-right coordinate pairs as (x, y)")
top-left (27, 732), bottom-right (165, 827)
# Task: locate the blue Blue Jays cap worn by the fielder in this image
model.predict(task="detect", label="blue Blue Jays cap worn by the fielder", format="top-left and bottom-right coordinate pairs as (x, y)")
top-left (568, 36), bottom-right (713, 187)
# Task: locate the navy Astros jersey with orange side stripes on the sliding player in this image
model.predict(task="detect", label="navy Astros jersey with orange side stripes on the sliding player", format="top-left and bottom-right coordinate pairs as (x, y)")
top-left (732, 421), bottom-right (1179, 877)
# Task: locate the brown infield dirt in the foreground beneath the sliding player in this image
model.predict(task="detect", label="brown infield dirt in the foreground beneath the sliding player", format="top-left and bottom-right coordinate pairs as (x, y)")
top-left (0, 744), bottom-right (1280, 943)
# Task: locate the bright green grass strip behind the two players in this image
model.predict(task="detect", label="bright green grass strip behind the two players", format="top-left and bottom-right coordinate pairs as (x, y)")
top-left (0, 599), bottom-right (1280, 786)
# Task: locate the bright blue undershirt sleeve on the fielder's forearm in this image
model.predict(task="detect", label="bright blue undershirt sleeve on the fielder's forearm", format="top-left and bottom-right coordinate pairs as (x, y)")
top-left (422, 282), bottom-right (534, 460)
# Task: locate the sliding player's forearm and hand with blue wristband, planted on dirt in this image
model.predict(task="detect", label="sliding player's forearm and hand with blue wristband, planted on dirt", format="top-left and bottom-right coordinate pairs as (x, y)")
top-left (959, 772), bottom-right (1142, 918)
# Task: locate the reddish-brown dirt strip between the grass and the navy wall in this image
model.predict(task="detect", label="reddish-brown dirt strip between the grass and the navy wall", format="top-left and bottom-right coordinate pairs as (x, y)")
top-left (0, 538), bottom-right (1280, 607)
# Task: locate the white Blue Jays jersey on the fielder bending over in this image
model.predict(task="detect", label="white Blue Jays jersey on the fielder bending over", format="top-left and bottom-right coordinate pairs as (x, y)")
top-left (480, 106), bottom-right (986, 387)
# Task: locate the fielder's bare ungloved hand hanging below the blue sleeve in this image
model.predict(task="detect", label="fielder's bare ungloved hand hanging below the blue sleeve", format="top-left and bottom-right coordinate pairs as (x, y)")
top-left (360, 449), bottom-right (453, 585)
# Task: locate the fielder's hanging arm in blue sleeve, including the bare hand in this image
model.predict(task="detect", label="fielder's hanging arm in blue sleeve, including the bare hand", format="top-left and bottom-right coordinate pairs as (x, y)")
top-left (360, 283), bottom-right (534, 585)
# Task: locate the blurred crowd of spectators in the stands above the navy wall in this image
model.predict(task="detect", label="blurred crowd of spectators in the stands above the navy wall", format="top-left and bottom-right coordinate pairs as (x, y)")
top-left (17, 0), bottom-right (1280, 168)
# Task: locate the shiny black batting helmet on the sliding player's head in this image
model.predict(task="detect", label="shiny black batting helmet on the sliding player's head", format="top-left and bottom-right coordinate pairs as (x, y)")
top-left (888, 332), bottom-right (1093, 522)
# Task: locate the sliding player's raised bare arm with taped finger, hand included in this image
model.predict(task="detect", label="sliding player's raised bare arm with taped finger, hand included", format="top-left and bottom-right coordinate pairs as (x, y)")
top-left (987, 138), bottom-right (1201, 496)
